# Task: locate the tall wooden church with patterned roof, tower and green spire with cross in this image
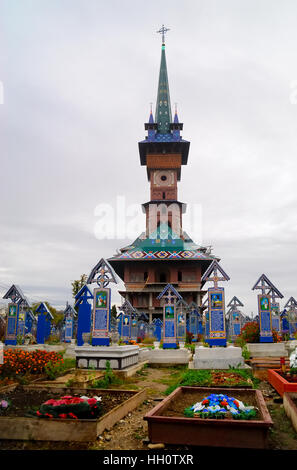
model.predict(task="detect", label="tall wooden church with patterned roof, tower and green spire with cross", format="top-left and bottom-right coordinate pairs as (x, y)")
top-left (108, 26), bottom-right (217, 321)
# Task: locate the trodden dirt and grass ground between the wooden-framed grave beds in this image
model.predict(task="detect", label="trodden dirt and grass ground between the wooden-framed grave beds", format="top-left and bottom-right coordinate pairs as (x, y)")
top-left (0, 366), bottom-right (297, 451)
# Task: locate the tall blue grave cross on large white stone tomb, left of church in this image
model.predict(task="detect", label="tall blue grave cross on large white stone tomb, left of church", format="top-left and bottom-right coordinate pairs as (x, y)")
top-left (87, 258), bottom-right (117, 346)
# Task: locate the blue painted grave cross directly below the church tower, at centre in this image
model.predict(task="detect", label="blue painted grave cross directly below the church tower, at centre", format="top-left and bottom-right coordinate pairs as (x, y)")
top-left (157, 284), bottom-right (182, 349)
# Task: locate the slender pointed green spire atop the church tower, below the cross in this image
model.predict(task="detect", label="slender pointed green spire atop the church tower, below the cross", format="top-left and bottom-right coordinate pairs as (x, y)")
top-left (155, 42), bottom-right (172, 134)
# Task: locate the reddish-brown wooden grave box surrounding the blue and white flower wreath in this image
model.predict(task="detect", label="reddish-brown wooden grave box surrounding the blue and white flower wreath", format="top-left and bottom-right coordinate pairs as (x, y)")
top-left (144, 387), bottom-right (273, 448)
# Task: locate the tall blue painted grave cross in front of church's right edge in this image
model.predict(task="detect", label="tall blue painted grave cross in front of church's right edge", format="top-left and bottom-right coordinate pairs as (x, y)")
top-left (201, 260), bottom-right (230, 346)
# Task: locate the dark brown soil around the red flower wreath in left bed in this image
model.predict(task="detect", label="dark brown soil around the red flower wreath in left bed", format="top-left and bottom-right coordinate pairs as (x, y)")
top-left (1, 386), bottom-right (131, 417)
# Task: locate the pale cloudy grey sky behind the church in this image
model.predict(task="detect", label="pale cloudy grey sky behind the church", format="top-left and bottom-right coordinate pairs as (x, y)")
top-left (0, 0), bottom-right (297, 315)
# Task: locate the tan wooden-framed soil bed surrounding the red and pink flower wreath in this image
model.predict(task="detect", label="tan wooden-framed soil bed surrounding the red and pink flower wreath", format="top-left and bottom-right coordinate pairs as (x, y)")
top-left (0, 386), bottom-right (145, 441)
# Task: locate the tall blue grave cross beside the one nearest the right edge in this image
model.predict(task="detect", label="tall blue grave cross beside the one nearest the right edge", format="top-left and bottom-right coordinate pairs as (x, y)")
top-left (252, 274), bottom-right (283, 343)
